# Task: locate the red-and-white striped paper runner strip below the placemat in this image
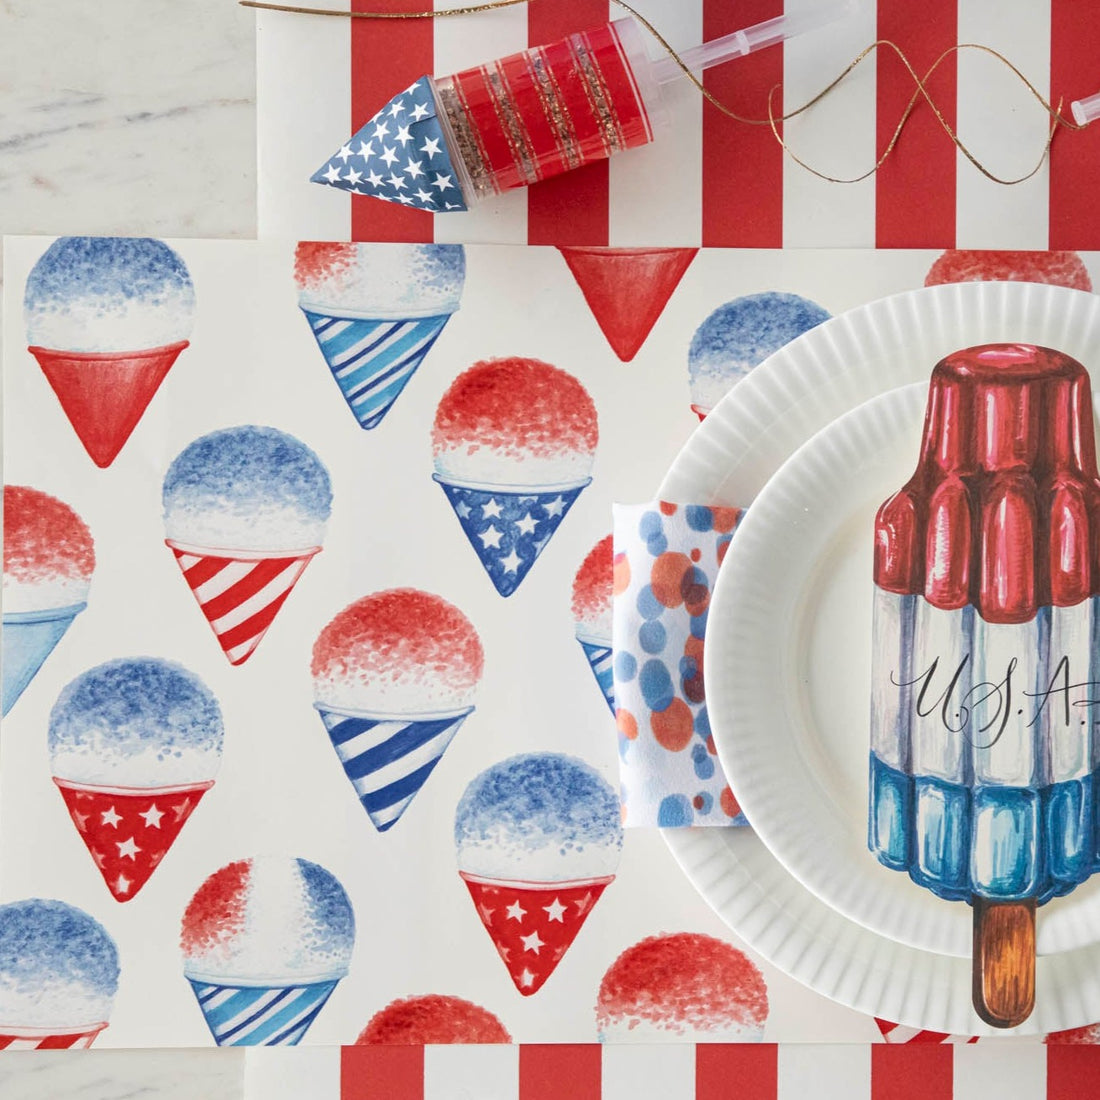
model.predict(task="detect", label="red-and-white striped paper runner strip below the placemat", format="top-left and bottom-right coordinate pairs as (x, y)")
top-left (245, 1041), bottom-right (1100, 1100)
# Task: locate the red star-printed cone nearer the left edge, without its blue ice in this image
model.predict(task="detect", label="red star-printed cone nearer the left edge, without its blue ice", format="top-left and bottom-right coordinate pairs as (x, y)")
top-left (54, 777), bottom-right (213, 901)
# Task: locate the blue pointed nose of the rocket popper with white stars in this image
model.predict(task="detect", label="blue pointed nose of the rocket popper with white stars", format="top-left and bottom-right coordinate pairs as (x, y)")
top-left (310, 76), bottom-right (466, 213)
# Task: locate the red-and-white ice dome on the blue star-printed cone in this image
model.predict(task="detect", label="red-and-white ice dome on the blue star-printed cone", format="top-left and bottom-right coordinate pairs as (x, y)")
top-left (431, 358), bottom-right (600, 486)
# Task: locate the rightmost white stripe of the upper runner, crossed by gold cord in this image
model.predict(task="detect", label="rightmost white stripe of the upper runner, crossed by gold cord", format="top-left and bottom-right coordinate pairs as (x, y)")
top-left (954, 0), bottom-right (1051, 249)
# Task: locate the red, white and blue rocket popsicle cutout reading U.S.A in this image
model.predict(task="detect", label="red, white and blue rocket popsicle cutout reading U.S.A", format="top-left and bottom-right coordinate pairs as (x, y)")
top-left (868, 344), bottom-right (1100, 1027)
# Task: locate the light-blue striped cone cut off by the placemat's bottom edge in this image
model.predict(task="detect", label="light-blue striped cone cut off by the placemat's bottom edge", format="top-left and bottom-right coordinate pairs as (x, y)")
top-left (187, 977), bottom-right (340, 1046)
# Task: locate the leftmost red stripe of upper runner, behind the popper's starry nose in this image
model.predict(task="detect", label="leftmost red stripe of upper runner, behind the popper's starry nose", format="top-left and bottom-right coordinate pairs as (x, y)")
top-left (351, 0), bottom-right (435, 241)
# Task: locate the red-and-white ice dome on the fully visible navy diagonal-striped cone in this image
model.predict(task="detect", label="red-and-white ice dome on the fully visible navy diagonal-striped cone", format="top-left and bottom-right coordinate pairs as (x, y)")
top-left (310, 589), bottom-right (485, 714)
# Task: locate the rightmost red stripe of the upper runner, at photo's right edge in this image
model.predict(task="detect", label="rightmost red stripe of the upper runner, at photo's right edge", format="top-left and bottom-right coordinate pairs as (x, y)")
top-left (1049, 0), bottom-right (1100, 249)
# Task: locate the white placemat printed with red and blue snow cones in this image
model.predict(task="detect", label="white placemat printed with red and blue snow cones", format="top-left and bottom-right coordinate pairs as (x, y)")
top-left (0, 238), bottom-right (1100, 1048)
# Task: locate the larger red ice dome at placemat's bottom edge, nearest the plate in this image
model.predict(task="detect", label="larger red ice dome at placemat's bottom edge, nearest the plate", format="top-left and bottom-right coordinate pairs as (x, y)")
top-left (596, 932), bottom-right (768, 1043)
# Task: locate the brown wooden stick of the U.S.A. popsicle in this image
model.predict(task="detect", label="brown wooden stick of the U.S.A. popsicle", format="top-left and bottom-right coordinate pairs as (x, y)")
top-left (972, 898), bottom-right (1035, 1027)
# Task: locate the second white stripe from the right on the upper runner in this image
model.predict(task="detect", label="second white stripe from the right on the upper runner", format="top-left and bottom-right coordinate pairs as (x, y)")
top-left (783, 0), bottom-right (878, 248)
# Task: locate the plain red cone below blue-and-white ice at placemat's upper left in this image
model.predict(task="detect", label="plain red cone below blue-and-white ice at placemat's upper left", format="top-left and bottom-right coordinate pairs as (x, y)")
top-left (30, 340), bottom-right (187, 468)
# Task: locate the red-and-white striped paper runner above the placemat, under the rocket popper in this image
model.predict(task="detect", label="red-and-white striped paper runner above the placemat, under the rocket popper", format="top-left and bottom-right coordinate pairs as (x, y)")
top-left (260, 0), bottom-right (1100, 250)
